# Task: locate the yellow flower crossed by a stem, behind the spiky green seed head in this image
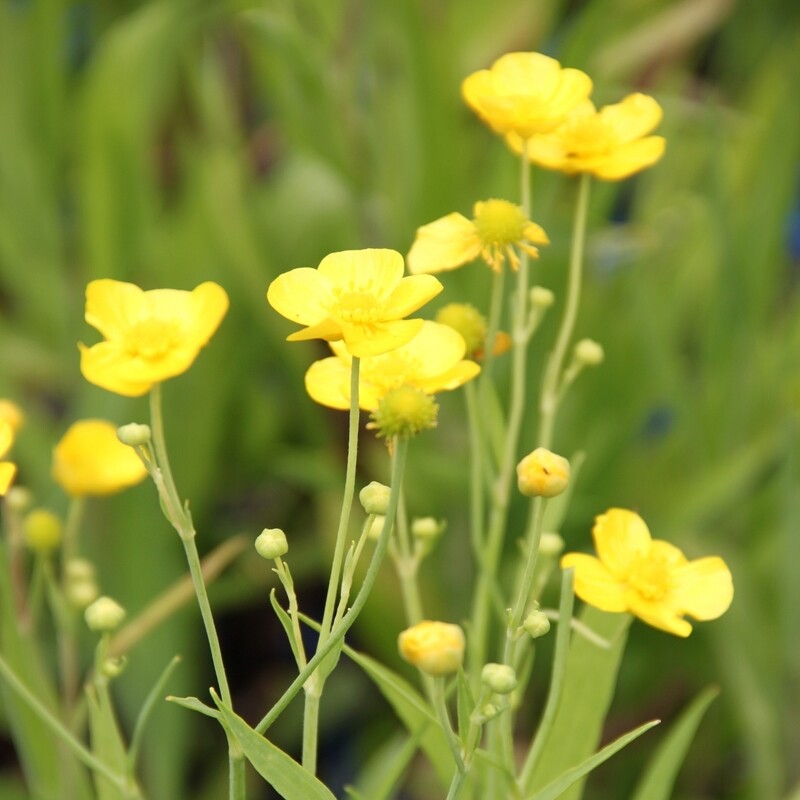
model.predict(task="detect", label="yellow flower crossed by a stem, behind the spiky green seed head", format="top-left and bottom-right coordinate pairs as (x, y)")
top-left (306, 320), bottom-right (480, 411)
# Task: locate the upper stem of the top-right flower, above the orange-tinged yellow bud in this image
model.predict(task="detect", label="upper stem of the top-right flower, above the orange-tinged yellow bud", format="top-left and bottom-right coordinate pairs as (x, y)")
top-left (538, 174), bottom-right (592, 447)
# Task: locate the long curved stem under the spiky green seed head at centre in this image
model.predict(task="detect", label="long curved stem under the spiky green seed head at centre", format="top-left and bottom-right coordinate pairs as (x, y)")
top-left (255, 440), bottom-right (408, 734)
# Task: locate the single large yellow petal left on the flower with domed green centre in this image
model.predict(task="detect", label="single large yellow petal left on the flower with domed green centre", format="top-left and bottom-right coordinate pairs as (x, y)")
top-left (406, 211), bottom-right (481, 275)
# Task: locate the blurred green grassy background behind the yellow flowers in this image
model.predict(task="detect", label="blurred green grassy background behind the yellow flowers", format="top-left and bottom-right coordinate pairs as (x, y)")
top-left (0, 0), bottom-right (800, 800)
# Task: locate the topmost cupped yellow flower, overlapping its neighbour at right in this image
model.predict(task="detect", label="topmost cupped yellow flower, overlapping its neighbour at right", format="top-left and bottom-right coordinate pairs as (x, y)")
top-left (461, 53), bottom-right (592, 139)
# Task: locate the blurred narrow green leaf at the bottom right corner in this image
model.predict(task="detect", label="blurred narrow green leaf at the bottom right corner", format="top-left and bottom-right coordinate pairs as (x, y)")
top-left (631, 686), bottom-right (719, 800)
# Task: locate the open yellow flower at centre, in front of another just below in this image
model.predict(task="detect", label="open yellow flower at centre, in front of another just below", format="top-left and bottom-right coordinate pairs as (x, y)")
top-left (267, 250), bottom-right (442, 358)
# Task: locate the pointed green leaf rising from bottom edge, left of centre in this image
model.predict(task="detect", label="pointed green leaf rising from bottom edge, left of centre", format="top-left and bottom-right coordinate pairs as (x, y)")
top-left (214, 702), bottom-right (336, 800)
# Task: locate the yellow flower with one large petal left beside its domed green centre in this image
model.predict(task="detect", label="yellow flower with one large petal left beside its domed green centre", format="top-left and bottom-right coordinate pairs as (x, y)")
top-left (408, 200), bottom-right (549, 274)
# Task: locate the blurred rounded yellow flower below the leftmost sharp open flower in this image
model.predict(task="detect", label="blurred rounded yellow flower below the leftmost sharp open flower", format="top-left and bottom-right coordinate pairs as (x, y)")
top-left (53, 419), bottom-right (147, 497)
